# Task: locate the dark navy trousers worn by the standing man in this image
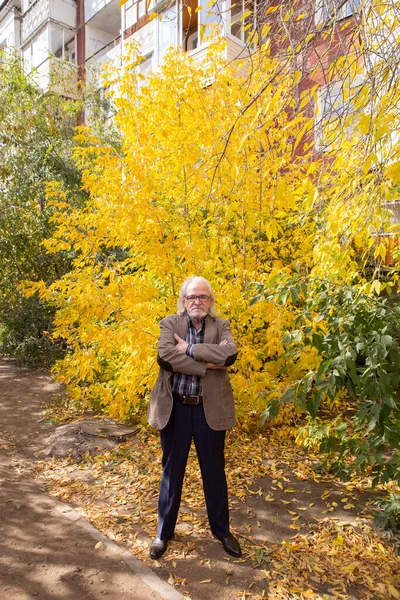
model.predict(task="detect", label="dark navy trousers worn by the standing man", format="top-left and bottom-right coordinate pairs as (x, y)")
top-left (157, 401), bottom-right (229, 540)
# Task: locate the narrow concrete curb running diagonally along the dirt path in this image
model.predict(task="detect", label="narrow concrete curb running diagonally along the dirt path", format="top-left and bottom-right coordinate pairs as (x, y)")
top-left (53, 498), bottom-right (187, 600)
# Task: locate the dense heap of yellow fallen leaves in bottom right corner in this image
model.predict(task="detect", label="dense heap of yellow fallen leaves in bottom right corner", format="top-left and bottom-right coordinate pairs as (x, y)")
top-left (265, 518), bottom-right (400, 600)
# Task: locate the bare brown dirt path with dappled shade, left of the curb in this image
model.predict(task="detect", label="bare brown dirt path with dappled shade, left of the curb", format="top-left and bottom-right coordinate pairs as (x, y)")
top-left (0, 360), bottom-right (183, 600)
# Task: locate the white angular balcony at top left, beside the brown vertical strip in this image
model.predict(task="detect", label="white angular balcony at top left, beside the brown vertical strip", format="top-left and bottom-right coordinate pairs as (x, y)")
top-left (21, 0), bottom-right (76, 44)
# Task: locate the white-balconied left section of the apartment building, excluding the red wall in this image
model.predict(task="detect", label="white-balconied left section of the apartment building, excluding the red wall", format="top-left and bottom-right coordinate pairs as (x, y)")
top-left (0, 0), bottom-right (254, 91)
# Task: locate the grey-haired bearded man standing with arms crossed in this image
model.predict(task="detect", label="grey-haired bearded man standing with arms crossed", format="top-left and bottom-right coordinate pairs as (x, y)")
top-left (148, 277), bottom-right (241, 559)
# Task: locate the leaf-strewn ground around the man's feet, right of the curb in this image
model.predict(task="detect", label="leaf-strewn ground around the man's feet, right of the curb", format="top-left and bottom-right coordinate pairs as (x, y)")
top-left (39, 410), bottom-right (400, 600)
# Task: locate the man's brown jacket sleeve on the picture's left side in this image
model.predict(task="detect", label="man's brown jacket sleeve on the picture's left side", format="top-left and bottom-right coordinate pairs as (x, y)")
top-left (157, 319), bottom-right (209, 377)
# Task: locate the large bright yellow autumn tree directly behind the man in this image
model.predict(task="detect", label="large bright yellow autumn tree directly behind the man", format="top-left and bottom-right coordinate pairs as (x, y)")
top-left (30, 19), bottom-right (393, 450)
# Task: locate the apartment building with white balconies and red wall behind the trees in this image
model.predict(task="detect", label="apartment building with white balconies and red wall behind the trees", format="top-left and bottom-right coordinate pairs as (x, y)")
top-left (0, 0), bottom-right (394, 176)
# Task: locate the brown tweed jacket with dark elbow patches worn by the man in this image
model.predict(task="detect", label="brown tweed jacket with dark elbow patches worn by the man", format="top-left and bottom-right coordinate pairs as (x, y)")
top-left (147, 313), bottom-right (237, 431)
